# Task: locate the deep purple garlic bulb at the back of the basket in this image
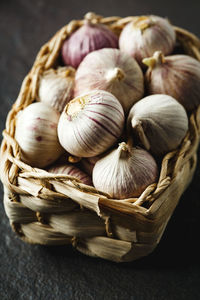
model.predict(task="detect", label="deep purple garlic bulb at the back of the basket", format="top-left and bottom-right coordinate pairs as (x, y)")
top-left (62, 20), bottom-right (118, 68)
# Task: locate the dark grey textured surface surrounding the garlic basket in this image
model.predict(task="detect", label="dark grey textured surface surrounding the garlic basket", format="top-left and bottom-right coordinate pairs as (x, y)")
top-left (0, 0), bottom-right (200, 300)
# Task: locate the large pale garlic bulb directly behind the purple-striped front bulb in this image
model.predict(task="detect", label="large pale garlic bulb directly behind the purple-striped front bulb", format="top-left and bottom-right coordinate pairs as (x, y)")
top-left (74, 48), bottom-right (144, 113)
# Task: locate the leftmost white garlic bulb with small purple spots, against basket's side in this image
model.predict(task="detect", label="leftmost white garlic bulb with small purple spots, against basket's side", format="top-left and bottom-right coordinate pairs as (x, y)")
top-left (15, 102), bottom-right (63, 168)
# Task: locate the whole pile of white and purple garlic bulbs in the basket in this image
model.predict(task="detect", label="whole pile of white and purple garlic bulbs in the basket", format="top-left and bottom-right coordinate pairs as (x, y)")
top-left (15, 15), bottom-right (200, 199)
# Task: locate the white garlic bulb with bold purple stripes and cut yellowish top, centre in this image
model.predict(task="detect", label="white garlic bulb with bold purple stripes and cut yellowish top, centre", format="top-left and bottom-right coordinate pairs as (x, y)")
top-left (58, 90), bottom-right (124, 157)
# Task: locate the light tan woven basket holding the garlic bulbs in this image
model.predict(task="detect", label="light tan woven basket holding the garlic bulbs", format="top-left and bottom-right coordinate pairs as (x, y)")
top-left (0, 13), bottom-right (200, 262)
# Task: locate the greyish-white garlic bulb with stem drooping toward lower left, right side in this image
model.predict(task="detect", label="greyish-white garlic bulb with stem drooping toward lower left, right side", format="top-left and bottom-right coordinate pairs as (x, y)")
top-left (127, 94), bottom-right (188, 155)
